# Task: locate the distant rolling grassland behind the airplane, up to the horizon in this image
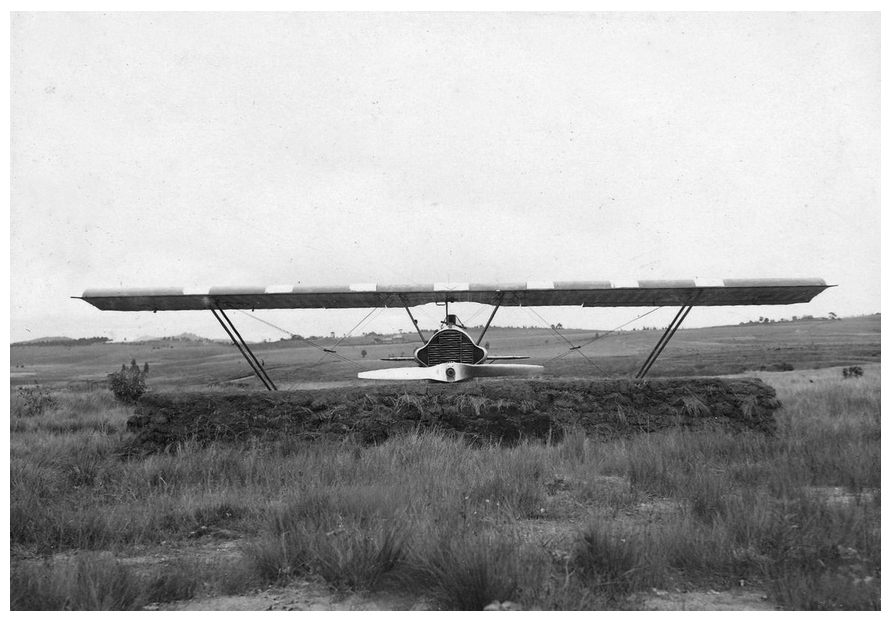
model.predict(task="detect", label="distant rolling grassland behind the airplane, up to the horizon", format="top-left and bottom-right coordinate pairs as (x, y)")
top-left (11, 315), bottom-right (880, 390)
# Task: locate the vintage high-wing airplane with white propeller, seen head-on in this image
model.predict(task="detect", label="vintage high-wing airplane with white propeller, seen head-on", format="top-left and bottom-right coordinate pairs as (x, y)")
top-left (75, 279), bottom-right (833, 391)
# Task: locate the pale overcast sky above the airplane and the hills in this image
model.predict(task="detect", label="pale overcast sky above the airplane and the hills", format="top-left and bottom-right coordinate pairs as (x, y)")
top-left (10, 13), bottom-right (880, 341)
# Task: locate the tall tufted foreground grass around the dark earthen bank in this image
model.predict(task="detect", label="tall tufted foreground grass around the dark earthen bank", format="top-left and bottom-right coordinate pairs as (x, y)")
top-left (10, 321), bottom-right (881, 610)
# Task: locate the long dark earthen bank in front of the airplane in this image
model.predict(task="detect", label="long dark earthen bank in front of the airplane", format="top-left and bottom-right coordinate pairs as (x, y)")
top-left (124, 378), bottom-right (780, 453)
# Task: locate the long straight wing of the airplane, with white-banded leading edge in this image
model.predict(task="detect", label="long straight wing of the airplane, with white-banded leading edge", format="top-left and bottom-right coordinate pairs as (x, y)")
top-left (81, 279), bottom-right (831, 311)
